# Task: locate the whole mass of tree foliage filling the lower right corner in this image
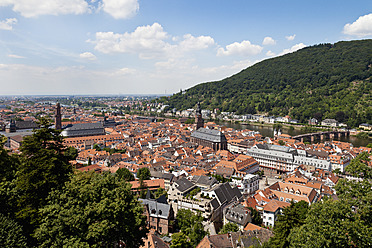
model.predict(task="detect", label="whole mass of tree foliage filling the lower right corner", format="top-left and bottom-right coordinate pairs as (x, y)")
top-left (263, 153), bottom-right (372, 248)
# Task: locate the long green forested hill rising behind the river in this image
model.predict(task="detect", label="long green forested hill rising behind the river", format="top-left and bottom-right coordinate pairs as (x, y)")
top-left (162, 40), bottom-right (372, 127)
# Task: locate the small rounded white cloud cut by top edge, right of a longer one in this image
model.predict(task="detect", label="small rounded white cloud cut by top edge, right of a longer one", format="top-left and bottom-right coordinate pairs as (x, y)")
top-left (102, 0), bottom-right (139, 19)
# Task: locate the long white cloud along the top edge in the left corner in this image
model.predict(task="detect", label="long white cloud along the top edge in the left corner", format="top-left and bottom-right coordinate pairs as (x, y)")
top-left (0, 0), bottom-right (89, 17)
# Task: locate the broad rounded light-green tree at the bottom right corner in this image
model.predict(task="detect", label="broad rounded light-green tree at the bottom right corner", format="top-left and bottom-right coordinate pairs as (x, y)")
top-left (288, 199), bottom-right (372, 248)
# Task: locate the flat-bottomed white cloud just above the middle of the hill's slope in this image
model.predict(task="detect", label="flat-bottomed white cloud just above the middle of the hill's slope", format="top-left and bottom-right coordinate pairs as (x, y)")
top-left (217, 40), bottom-right (262, 56)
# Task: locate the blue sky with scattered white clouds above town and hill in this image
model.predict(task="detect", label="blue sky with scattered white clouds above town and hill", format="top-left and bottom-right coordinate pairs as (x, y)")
top-left (0, 0), bottom-right (372, 95)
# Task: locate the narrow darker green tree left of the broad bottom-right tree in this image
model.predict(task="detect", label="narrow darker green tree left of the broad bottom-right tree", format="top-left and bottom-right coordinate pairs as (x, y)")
top-left (269, 201), bottom-right (309, 248)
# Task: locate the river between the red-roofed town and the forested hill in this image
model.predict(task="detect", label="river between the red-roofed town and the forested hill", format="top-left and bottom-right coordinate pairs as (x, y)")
top-left (218, 122), bottom-right (372, 147)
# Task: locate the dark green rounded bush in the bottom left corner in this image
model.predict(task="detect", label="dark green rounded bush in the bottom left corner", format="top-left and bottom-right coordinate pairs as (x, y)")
top-left (0, 213), bottom-right (27, 248)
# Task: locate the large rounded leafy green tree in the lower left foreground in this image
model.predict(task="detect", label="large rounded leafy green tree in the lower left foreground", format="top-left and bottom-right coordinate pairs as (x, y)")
top-left (35, 172), bottom-right (147, 247)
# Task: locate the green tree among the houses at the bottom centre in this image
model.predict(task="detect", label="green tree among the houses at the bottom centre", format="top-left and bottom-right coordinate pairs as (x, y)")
top-left (176, 209), bottom-right (208, 247)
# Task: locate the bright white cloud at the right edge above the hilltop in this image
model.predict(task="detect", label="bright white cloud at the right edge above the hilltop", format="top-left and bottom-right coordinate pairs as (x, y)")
top-left (343, 13), bottom-right (372, 37)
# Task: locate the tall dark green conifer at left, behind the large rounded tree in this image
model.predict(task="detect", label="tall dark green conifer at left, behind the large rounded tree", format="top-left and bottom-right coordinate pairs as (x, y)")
top-left (15, 119), bottom-right (73, 242)
